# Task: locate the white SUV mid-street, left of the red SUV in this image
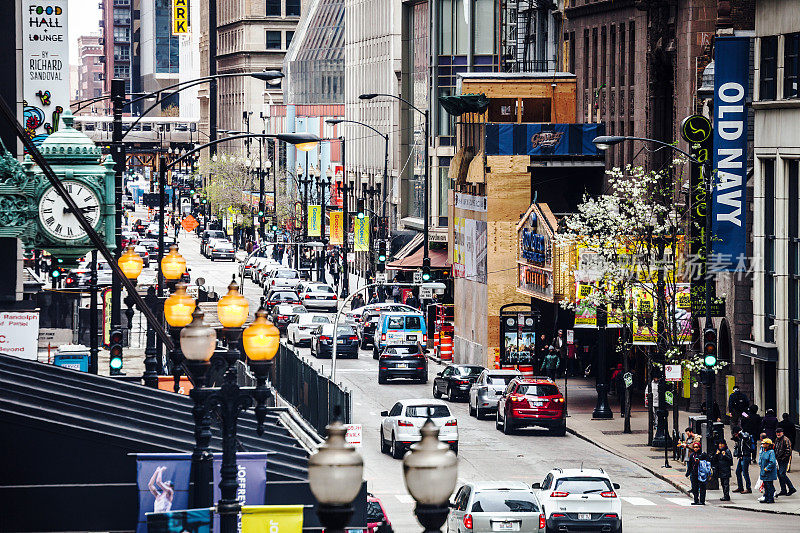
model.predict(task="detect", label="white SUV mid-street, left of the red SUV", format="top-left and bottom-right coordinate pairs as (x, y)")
top-left (381, 398), bottom-right (458, 459)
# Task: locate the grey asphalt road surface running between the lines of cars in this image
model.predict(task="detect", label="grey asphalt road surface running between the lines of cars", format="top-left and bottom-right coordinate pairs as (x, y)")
top-left (175, 234), bottom-right (797, 533)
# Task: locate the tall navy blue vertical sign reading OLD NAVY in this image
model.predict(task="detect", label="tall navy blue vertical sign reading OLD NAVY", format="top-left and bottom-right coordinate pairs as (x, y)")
top-left (712, 37), bottom-right (750, 271)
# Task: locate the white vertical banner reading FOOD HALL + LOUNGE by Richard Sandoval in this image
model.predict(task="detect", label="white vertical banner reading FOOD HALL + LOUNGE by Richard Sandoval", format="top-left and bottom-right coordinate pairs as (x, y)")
top-left (20, 0), bottom-right (70, 146)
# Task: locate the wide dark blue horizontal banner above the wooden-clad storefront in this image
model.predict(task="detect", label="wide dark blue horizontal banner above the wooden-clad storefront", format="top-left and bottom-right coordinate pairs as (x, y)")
top-left (486, 123), bottom-right (606, 157)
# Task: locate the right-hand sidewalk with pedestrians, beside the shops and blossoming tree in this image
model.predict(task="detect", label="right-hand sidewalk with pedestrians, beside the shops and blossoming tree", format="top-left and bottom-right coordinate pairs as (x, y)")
top-left (558, 379), bottom-right (800, 515)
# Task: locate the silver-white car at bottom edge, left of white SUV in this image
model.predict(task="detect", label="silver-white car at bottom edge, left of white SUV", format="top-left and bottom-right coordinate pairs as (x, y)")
top-left (447, 481), bottom-right (549, 533)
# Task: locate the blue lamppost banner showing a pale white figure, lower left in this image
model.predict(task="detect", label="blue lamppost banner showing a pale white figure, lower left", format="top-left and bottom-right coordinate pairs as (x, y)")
top-left (136, 453), bottom-right (192, 533)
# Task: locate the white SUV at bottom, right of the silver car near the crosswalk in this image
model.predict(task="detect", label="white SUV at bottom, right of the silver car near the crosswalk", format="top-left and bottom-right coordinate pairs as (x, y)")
top-left (533, 468), bottom-right (622, 533)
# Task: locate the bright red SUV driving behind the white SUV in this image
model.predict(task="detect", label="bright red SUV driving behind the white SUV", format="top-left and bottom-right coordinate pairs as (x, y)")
top-left (496, 377), bottom-right (567, 436)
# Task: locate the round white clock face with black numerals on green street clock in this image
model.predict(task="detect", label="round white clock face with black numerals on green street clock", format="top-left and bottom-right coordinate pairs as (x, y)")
top-left (39, 181), bottom-right (100, 241)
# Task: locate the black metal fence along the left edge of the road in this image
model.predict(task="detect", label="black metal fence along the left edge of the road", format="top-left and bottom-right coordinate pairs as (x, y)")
top-left (273, 344), bottom-right (353, 437)
